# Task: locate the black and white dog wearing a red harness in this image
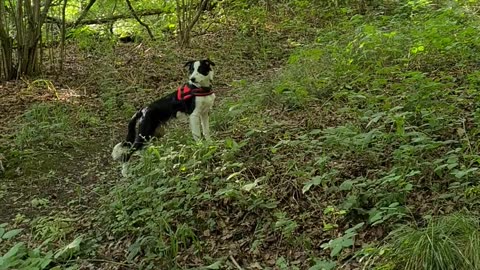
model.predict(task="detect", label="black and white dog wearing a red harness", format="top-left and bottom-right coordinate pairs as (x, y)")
top-left (112, 59), bottom-right (215, 172)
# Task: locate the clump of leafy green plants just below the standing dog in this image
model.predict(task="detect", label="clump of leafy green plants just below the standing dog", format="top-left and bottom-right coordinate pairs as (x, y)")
top-left (103, 139), bottom-right (276, 267)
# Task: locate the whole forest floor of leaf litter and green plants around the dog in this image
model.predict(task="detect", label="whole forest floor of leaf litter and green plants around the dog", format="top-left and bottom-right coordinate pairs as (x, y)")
top-left (4, 6), bottom-right (480, 270)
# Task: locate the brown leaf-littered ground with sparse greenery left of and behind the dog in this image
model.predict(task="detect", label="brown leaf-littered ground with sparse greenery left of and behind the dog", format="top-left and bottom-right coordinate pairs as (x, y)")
top-left (0, 40), bottom-right (290, 269)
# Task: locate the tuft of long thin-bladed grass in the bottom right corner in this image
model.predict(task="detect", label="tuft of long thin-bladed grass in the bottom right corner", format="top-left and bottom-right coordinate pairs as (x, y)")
top-left (390, 214), bottom-right (480, 270)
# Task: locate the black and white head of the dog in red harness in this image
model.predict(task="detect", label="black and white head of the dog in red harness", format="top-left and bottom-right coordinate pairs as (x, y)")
top-left (185, 59), bottom-right (215, 87)
